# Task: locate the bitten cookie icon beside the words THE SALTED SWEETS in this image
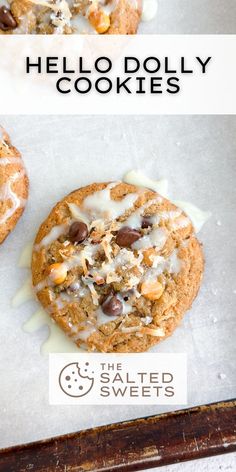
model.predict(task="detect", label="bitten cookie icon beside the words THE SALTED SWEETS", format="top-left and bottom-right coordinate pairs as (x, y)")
top-left (59, 362), bottom-right (94, 398)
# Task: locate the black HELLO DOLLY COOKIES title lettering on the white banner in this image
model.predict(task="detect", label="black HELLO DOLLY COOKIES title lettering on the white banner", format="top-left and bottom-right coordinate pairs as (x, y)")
top-left (25, 56), bottom-right (212, 95)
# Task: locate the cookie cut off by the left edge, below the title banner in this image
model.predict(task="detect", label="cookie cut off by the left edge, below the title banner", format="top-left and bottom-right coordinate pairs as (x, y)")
top-left (0, 127), bottom-right (29, 244)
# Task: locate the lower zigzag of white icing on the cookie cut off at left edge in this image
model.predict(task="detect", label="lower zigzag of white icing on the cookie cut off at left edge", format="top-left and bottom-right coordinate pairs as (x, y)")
top-left (0, 169), bottom-right (26, 224)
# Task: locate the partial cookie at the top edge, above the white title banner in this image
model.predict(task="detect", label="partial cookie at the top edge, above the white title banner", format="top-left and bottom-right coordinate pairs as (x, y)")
top-left (0, 0), bottom-right (142, 34)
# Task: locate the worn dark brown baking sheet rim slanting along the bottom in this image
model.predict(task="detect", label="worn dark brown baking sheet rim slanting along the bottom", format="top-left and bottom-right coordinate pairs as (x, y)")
top-left (0, 400), bottom-right (236, 472)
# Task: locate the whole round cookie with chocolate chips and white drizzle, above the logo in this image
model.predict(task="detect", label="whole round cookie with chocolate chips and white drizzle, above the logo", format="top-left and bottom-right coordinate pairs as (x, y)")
top-left (32, 182), bottom-right (204, 352)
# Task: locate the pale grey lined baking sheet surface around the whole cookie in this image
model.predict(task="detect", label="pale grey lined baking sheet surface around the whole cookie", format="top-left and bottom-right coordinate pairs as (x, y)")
top-left (0, 116), bottom-right (236, 447)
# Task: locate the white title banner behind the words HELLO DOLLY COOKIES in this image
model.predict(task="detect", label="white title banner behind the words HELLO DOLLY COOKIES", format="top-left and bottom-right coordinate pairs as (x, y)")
top-left (0, 35), bottom-right (236, 115)
